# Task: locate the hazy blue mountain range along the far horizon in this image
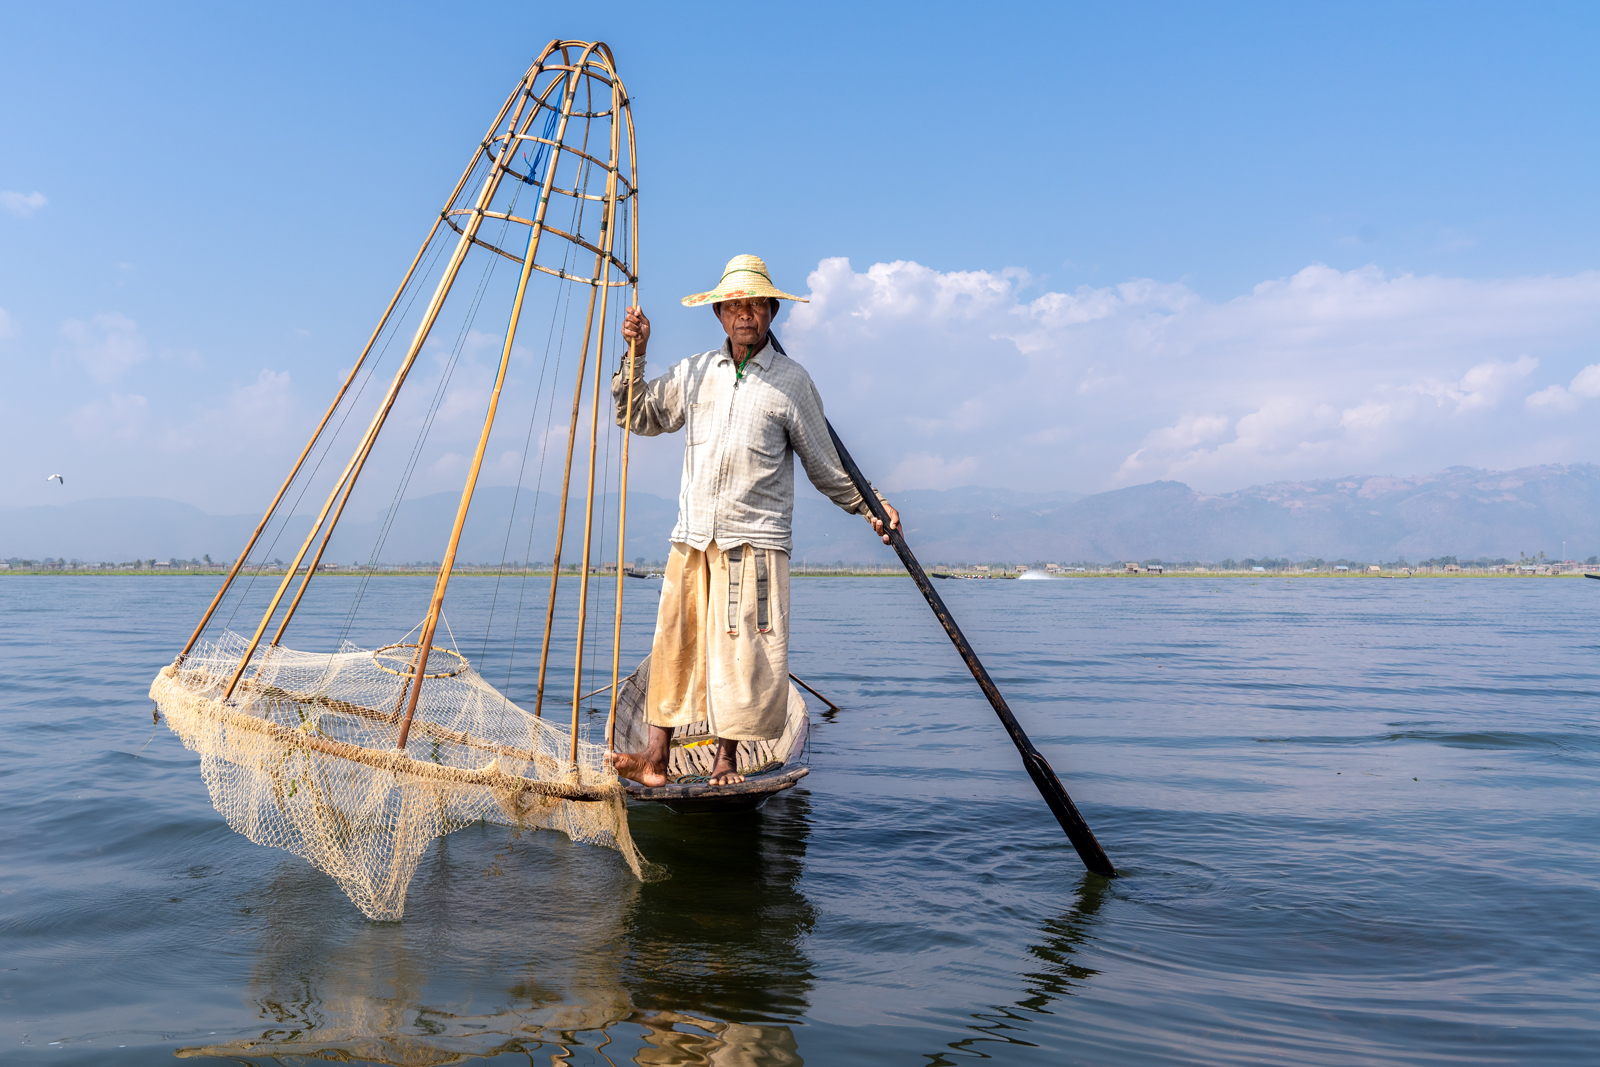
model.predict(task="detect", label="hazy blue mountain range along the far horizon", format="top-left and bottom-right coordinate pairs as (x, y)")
top-left (0, 464), bottom-right (1600, 565)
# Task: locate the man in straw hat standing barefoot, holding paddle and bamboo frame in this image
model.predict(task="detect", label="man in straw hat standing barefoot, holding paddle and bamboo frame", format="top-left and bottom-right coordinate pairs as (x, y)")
top-left (611, 256), bottom-right (899, 787)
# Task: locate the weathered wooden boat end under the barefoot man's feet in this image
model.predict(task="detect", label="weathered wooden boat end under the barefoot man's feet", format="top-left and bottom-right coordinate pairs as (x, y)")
top-left (614, 656), bottom-right (811, 814)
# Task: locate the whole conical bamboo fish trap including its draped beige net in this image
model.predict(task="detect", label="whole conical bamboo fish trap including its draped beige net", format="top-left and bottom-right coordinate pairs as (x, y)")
top-left (150, 42), bottom-right (648, 920)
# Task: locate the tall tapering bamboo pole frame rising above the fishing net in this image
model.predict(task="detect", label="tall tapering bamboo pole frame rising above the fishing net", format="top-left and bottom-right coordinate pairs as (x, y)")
top-left (176, 40), bottom-right (638, 777)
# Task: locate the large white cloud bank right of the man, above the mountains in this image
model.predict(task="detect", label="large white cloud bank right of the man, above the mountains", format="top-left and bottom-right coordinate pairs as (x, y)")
top-left (779, 259), bottom-right (1600, 491)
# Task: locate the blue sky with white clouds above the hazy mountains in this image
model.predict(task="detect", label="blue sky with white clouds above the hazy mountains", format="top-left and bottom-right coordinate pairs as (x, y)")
top-left (0, 2), bottom-right (1600, 514)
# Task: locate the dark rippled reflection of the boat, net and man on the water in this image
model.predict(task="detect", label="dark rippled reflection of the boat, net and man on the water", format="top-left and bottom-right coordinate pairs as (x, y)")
top-left (178, 790), bottom-right (814, 1067)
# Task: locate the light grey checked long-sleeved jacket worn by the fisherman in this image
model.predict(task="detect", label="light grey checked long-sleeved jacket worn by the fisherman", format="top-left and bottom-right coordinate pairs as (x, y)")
top-left (611, 341), bottom-right (882, 552)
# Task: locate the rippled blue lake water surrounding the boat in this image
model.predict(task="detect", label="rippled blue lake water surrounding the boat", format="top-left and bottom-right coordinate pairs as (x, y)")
top-left (0, 577), bottom-right (1600, 1065)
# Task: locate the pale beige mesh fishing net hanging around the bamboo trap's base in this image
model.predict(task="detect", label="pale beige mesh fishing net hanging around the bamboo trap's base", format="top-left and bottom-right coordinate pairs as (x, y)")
top-left (150, 632), bottom-right (653, 920)
